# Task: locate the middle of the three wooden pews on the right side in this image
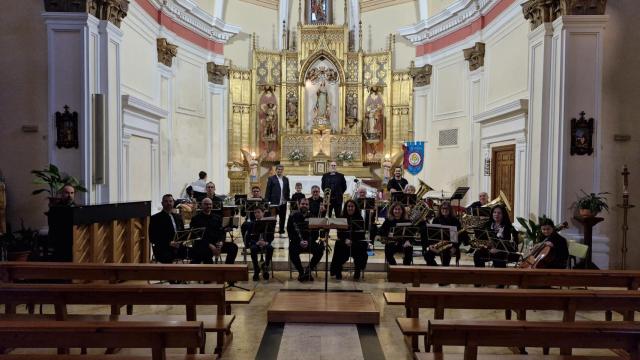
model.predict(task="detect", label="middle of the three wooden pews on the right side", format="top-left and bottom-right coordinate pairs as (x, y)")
top-left (396, 288), bottom-right (640, 351)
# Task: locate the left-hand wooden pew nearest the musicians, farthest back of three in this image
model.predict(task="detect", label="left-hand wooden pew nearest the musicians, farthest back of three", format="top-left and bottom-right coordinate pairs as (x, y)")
top-left (0, 261), bottom-right (255, 315)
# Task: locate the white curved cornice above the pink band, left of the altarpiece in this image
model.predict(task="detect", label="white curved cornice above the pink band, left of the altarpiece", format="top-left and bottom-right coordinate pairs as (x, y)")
top-left (146, 0), bottom-right (240, 44)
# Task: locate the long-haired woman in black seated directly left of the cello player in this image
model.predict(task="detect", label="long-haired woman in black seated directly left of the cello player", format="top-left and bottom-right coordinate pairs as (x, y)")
top-left (473, 205), bottom-right (518, 268)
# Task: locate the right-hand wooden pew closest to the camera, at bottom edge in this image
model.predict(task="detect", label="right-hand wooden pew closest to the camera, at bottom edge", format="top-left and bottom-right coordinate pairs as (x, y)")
top-left (422, 320), bottom-right (640, 360)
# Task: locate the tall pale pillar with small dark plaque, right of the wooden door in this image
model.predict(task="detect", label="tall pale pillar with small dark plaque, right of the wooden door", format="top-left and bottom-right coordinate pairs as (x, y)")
top-left (548, 12), bottom-right (609, 268)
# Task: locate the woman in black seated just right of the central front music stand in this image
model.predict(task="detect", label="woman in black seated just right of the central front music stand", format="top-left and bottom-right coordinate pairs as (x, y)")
top-left (330, 200), bottom-right (367, 280)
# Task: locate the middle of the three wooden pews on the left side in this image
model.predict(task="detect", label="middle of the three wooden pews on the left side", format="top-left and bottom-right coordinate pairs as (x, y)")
top-left (0, 284), bottom-right (235, 354)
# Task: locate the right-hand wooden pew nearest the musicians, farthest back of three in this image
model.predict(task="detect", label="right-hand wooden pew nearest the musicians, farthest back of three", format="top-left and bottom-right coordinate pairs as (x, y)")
top-left (384, 265), bottom-right (640, 304)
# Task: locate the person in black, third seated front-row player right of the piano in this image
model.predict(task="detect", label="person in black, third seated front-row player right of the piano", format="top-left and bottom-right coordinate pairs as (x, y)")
top-left (241, 206), bottom-right (273, 281)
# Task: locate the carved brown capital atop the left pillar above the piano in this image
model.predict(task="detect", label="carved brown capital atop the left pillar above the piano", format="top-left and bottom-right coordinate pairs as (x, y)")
top-left (44, 0), bottom-right (129, 27)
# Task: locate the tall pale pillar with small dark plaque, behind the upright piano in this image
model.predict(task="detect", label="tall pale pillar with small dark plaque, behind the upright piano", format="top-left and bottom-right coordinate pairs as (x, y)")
top-left (42, 0), bottom-right (129, 203)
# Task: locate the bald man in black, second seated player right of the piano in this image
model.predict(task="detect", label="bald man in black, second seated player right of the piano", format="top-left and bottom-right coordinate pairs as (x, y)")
top-left (190, 198), bottom-right (238, 264)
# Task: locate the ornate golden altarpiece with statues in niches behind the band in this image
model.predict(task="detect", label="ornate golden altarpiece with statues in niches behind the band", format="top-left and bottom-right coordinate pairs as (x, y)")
top-left (228, 2), bottom-right (417, 193)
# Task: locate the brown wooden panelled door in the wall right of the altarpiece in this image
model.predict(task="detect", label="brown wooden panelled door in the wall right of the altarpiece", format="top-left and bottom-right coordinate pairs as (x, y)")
top-left (491, 145), bottom-right (516, 211)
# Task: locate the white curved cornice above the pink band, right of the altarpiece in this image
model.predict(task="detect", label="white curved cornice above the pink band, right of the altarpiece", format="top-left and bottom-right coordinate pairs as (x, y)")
top-left (398, 0), bottom-right (501, 45)
